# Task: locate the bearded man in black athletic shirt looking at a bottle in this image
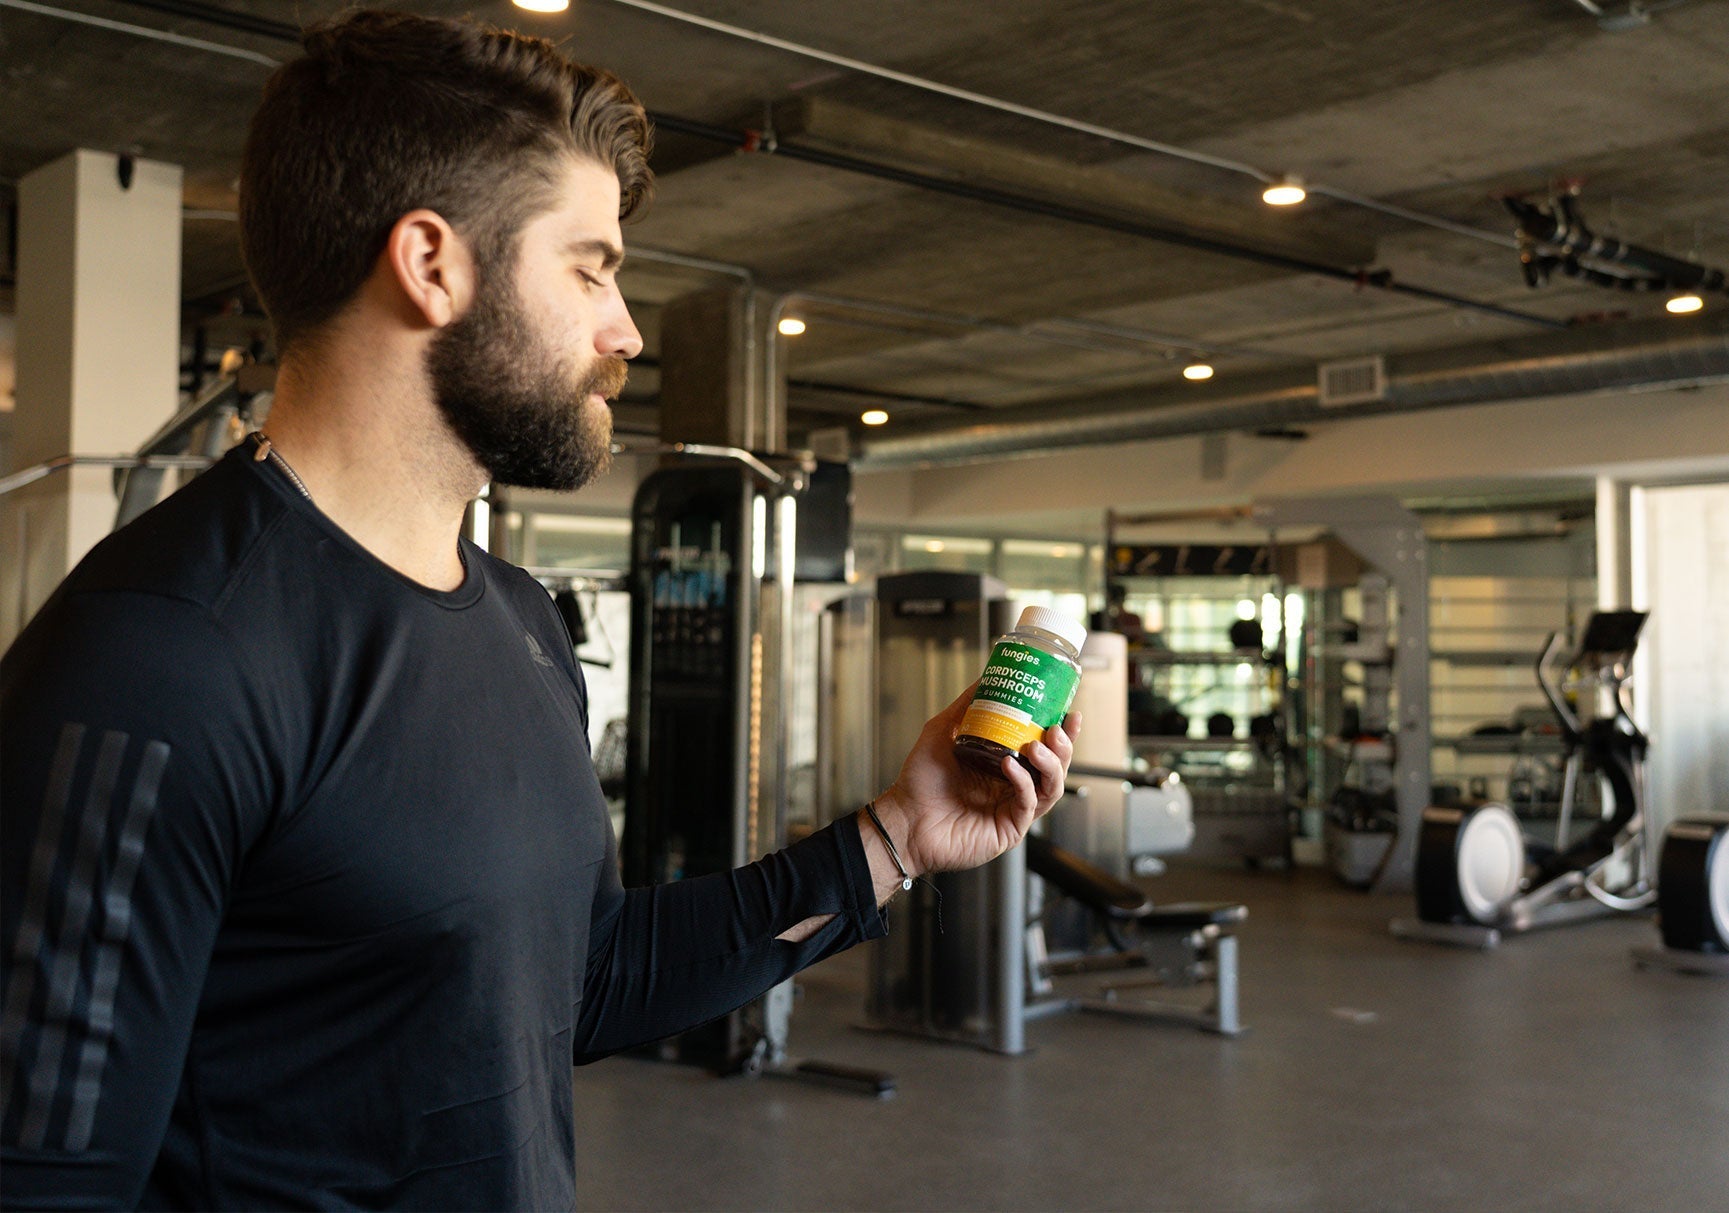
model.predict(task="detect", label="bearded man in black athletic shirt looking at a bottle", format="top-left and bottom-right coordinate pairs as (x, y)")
top-left (0, 12), bottom-right (1072, 1210)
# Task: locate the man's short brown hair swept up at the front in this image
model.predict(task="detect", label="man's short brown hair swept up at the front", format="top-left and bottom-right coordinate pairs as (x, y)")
top-left (240, 10), bottom-right (654, 352)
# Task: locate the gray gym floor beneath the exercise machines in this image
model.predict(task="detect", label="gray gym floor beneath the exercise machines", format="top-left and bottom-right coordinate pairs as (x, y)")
top-left (576, 867), bottom-right (1729, 1211)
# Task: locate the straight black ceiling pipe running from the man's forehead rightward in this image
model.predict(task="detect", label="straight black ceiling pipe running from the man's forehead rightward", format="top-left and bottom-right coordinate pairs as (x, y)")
top-left (648, 114), bottom-right (1566, 328)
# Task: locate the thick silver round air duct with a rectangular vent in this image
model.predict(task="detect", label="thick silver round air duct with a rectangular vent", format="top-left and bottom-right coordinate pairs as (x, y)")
top-left (854, 313), bottom-right (1729, 470)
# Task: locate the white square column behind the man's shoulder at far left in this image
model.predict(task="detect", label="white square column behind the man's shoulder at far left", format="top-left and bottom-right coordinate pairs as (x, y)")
top-left (0, 150), bottom-right (182, 645)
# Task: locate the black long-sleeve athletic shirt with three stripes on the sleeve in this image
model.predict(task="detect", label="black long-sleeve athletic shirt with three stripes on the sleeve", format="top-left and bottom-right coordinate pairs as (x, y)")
top-left (0, 442), bottom-right (882, 1210)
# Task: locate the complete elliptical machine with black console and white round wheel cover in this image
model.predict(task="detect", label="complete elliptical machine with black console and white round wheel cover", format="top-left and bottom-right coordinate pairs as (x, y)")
top-left (1392, 610), bottom-right (1656, 949)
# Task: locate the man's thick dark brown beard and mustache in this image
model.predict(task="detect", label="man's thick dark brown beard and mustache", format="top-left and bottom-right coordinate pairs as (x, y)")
top-left (427, 271), bottom-right (628, 491)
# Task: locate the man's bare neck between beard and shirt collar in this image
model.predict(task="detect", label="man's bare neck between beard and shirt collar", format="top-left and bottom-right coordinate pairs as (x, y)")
top-left (252, 340), bottom-right (486, 589)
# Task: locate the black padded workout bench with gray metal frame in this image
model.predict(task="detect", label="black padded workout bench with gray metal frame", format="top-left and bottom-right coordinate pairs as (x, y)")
top-left (1025, 835), bottom-right (1248, 1037)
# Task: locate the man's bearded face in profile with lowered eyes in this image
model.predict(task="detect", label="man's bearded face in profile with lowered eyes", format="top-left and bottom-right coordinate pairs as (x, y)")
top-left (427, 161), bottom-right (641, 489)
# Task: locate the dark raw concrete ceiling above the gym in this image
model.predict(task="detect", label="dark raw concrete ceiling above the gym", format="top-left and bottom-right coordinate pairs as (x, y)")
top-left (0, 0), bottom-right (1729, 466)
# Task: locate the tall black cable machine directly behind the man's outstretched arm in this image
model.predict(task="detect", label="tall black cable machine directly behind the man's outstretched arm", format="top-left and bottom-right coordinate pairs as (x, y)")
top-left (621, 446), bottom-right (894, 1096)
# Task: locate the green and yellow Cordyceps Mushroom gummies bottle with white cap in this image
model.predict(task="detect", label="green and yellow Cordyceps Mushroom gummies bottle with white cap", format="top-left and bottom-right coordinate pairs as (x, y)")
top-left (954, 607), bottom-right (1086, 779)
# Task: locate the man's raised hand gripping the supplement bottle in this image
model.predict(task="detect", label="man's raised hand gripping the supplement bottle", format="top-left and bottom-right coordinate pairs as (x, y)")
top-left (859, 688), bottom-right (1081, 899)
